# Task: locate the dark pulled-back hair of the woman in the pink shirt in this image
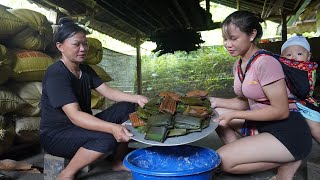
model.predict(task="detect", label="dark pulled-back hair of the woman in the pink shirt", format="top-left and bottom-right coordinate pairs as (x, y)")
top-left (221, 11), bottom-right (264, 41)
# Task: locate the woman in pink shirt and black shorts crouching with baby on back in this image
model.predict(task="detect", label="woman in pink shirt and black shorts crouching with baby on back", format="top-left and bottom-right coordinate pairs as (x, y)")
top-left (210, 11), bottom-right (312, 180)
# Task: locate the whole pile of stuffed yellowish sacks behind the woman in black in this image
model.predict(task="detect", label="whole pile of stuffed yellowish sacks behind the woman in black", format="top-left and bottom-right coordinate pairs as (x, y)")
top-left (0, 7), bottom-right (112, 155)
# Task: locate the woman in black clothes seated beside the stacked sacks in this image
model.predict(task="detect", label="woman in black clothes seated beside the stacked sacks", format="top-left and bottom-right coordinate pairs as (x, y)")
top-left (40, 18), bottom-right (148, 179)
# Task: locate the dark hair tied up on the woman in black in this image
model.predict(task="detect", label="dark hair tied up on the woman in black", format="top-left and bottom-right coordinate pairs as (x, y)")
top-left (53, 17), bottom-right (87, 44)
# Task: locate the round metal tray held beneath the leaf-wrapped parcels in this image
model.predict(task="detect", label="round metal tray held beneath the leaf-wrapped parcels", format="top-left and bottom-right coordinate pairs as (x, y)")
top-left (124, 120), bottom-right (218, 146)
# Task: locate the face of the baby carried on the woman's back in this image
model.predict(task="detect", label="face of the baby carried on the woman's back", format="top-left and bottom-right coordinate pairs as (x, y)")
top-left (281, 45), bottom-right (310, 61)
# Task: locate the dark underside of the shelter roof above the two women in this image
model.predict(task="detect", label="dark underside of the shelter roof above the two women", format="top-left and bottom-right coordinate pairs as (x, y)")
top-left (29, 0), bottom-right (319, 47)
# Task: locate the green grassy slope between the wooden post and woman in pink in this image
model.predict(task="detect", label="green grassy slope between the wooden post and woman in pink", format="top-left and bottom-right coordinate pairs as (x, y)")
top-left (142, 46), bottom-right (235, 97)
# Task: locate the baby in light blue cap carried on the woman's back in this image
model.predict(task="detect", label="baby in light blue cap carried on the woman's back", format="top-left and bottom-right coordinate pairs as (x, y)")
top-left (281, 36), bottom-right (320, 143)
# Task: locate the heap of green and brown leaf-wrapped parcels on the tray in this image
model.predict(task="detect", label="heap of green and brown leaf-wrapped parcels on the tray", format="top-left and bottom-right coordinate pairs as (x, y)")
top-left (129, 90), bottom-right (213, 142)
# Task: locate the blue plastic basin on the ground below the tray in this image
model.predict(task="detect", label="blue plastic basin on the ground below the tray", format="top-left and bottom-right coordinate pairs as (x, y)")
top-left (124, 145), bottom-right (221, 180)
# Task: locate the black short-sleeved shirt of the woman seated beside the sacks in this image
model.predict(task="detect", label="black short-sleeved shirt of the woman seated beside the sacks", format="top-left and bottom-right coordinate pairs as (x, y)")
top-left (40, 61), bottom-right (103, 133)
